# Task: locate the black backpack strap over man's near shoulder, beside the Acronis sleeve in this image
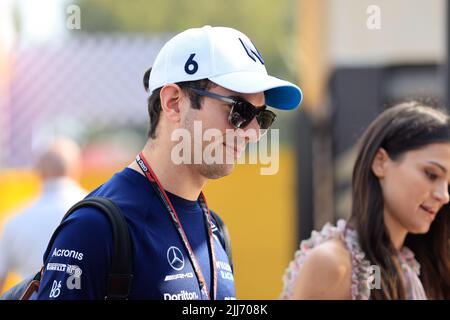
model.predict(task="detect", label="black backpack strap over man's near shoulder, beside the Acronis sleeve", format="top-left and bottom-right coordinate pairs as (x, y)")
top-left (58, 197), bottom-right (133, 300)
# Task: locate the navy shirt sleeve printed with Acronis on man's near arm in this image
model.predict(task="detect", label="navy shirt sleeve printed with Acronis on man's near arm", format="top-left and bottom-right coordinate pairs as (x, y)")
top-left (32, 208), bottom-right (113, 300)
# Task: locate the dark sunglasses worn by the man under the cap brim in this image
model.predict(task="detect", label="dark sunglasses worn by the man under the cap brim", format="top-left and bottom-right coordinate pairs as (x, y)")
top-left (191, 88), bottom-right (277, 130)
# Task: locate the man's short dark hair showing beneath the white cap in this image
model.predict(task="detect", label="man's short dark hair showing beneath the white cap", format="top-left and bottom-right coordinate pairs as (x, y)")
top-left (143, 68), bottom-right (215, 139)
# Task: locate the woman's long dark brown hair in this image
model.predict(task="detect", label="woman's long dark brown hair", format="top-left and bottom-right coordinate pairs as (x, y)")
top-left (349, 101), bottom-right (450, 299)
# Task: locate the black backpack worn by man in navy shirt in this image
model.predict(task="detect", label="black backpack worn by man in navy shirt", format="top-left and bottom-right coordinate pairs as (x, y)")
top-left (0, 197), bottom-right (233, 300)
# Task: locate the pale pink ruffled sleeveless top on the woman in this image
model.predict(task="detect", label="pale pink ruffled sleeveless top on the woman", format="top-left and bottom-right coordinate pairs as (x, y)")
top-left (280, 220), bottom-right (427, 300)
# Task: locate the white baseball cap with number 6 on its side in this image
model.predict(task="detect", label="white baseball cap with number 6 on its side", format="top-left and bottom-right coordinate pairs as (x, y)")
top-left (149, 26), bottom-right (302, 110)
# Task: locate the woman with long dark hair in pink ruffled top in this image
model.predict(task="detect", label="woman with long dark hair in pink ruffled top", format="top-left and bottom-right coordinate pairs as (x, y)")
top-left (281, 102), bottom-right (450, 299)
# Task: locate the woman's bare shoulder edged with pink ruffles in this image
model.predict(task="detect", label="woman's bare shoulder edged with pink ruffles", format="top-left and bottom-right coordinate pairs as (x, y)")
top-left (281, 220), bottom-right (366, 299)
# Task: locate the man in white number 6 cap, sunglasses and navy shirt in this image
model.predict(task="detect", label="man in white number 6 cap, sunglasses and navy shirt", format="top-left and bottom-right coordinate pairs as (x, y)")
top-left (32, 26), bottom-right (301, 300)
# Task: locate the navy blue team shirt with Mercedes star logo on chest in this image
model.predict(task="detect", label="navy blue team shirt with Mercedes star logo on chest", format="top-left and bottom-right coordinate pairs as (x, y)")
top-left (32, 168), bottom-right (235, 300)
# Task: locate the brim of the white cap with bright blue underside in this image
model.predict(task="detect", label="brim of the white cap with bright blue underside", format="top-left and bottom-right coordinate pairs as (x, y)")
top-left (209, 72), bottom-right (303, 110)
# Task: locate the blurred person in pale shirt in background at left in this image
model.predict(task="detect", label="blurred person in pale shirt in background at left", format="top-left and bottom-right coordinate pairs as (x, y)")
top-left (0, 138), bottom-right (87, 292)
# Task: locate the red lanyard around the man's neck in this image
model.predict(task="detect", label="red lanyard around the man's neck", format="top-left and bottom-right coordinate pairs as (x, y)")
top-left (136, 152), bottom-right (217, 300)
